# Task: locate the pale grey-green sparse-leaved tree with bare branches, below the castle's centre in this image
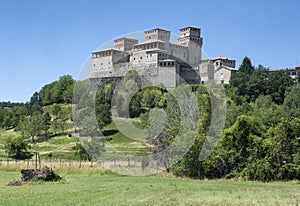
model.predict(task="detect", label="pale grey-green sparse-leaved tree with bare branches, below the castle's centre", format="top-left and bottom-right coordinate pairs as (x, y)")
top-left (143, 85), bottom-right (199, 172)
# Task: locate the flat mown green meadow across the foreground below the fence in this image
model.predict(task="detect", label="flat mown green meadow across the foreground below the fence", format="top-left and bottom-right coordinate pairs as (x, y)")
top-left (0, 170), bottom-right (300, 206)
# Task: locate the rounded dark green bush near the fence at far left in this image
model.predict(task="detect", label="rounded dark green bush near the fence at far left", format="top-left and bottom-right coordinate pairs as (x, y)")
top-left (4, 136), bottom-right (29, 159)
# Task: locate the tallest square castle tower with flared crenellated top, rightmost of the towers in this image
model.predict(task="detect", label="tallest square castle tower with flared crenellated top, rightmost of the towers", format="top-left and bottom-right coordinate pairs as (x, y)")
top-left (178, 26), bottom-right (203, 67)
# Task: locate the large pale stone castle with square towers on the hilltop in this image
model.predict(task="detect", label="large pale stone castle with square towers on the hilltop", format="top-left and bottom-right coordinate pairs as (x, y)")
top-left (89, 26), bottom-right (236, 90)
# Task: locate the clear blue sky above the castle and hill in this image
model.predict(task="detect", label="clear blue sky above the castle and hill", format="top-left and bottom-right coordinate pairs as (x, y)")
top-left (0, 0), bottom-right (300, 102)
